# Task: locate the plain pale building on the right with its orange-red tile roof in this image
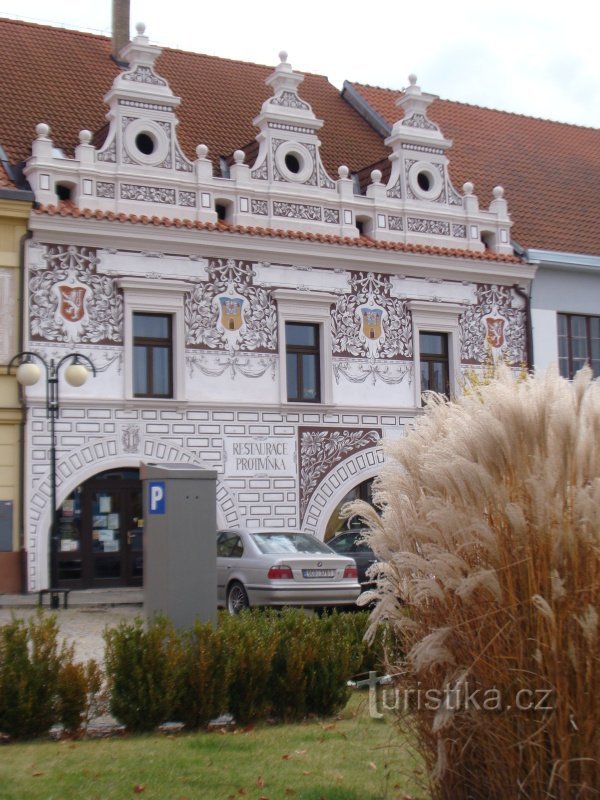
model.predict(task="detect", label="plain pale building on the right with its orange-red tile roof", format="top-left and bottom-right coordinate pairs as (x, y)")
top-left (342, 83), bottom-right (600, 378)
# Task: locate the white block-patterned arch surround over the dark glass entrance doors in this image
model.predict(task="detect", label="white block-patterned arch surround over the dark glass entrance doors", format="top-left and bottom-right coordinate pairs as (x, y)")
top-left (26, 436), bottom-right (240, 591)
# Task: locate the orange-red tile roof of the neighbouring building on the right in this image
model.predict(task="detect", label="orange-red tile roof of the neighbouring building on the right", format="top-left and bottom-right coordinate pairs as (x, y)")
top-left (352, 83), bottom-right (600, 255)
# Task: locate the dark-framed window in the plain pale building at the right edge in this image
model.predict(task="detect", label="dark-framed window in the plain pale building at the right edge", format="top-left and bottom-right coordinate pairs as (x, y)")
top-left (558, 314), bottom-right (600, 378)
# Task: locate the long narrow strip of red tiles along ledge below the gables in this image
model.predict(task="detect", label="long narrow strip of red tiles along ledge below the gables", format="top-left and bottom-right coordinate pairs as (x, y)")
top-left (35, 202), bottom-right (522, 264)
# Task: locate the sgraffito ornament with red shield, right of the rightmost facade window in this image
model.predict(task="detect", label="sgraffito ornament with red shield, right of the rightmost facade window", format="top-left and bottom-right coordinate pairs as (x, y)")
top-left (460, 284), bottom-right (527, 366)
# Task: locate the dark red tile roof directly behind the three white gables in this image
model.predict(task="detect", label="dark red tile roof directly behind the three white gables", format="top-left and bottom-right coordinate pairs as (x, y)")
top-left (0, 19), bottom-right (387, 179)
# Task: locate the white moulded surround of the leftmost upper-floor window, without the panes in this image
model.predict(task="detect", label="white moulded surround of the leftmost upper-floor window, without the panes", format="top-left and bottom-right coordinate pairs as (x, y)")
top-left (117, 277), bottom-right (187, 403)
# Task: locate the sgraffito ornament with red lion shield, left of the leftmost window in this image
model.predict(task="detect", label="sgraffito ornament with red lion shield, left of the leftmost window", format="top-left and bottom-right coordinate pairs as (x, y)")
top-left (29, 245), bottom-right (123, 344)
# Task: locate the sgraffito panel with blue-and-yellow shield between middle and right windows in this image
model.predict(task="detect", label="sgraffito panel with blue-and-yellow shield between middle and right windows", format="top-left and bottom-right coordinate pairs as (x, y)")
top-left (331, 272), bottom-right (412, 359)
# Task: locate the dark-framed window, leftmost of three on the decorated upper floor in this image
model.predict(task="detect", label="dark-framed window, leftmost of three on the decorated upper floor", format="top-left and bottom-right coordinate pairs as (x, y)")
top-left (133, 314), bottom-right (173, 397)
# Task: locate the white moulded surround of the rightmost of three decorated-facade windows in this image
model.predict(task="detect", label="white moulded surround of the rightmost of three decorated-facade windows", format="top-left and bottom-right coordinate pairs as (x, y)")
top-left (408, 300), bottom-right (466, 408)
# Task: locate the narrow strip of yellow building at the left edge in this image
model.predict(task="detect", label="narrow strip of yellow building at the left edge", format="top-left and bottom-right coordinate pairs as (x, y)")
top-left (0, 161), bottom-right (33, 592)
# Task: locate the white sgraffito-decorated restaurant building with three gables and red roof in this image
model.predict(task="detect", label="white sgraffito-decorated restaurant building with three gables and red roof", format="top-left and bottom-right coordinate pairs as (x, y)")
top-left (0, 22), bottom-right (534, 589)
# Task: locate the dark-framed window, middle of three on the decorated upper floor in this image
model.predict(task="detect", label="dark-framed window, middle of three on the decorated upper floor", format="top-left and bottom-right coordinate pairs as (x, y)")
top-left (285, 322), bottom-right (321, 403)
